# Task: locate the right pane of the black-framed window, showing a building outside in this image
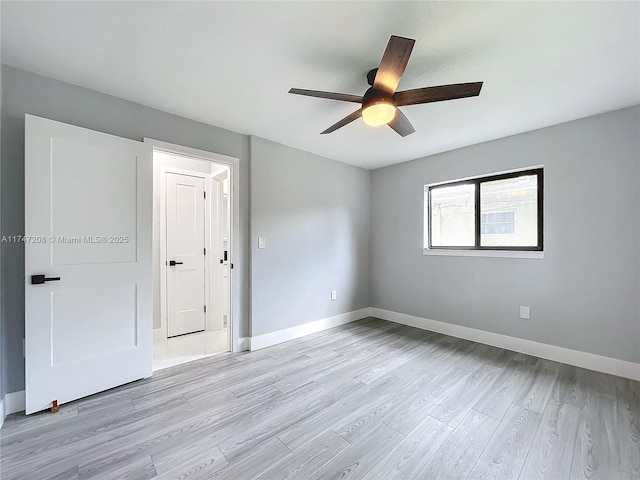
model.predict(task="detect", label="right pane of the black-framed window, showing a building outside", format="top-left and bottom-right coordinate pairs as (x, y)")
top-left (480, 175), bottom-right (538, 247)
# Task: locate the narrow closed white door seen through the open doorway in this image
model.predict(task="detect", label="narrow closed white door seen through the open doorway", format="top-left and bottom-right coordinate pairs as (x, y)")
top-left (166, 173), bottom-right (206, 337)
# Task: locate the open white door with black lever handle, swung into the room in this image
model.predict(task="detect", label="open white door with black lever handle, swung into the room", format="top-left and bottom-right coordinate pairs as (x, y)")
top-left (25, 115), bottom-right (153, 414)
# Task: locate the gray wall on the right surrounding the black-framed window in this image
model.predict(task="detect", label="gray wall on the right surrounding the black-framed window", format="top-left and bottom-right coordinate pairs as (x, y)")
top-left (371, 107), bottom-right (640, 362)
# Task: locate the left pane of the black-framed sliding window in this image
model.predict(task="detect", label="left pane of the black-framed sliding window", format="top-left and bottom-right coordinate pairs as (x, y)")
top-left (430, 184), bottom-right (476, 247)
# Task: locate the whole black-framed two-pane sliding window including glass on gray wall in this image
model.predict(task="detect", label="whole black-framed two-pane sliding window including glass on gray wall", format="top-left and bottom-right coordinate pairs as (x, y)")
top-left (425, 168), bottom-right (543, 251)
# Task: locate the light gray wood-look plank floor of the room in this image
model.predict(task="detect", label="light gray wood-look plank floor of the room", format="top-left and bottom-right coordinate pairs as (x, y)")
top-left (0, 319), bottom-right (640, 480)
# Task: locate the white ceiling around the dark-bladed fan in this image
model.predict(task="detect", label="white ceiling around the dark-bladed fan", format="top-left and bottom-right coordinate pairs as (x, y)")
top-left (1, 1), bottom-right (640, 168)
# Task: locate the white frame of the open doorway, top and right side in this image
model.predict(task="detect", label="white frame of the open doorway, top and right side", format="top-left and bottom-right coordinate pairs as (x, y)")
top-left (144, 137), bottom-right (240, 352)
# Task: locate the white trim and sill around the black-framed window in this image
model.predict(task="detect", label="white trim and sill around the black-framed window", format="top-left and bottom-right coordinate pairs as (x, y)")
top-left (422, 164), bottom-right (546, 260)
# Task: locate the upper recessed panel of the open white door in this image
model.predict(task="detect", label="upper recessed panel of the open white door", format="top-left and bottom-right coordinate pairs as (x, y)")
top-left (51, 138), bottom-right (137, 265)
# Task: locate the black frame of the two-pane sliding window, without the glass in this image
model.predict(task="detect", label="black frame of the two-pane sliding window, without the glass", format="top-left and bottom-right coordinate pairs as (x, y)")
top-left (424, 166), bottom-right (544, 252)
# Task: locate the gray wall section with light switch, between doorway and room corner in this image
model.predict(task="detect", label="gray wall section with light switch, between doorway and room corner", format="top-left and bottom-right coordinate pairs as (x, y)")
top-left (251, 137), bottom-right (371, 335)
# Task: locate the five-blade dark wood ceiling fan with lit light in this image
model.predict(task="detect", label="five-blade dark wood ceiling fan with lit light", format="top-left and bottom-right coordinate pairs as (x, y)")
top-left (289, 35), bottom-right (482, 137)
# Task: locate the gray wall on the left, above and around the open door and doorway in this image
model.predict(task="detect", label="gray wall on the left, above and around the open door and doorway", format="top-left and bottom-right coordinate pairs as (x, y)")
top-left (0, 65), bottom-right (249, 392)
